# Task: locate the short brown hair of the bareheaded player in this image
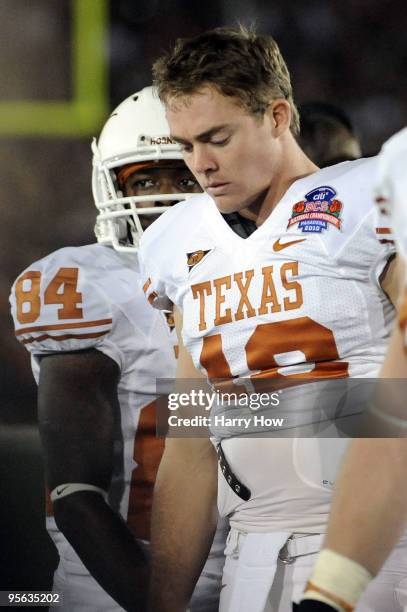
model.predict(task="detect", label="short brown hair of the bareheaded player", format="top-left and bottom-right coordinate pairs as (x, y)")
top-left (153, 26), bottom-right (300, 135)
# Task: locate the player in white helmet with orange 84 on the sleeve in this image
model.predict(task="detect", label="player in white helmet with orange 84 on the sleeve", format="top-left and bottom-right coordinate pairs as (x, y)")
top-left (11, 87), bottom-right (223, 612)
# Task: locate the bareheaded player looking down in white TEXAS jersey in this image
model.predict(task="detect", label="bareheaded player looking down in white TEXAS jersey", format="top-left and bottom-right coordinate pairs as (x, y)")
top-left (140, 28), bottom-right (407, 612)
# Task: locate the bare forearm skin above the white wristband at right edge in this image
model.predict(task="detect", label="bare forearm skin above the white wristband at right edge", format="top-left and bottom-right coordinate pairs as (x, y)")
top-left (324, 438), bottom-right (407, 575)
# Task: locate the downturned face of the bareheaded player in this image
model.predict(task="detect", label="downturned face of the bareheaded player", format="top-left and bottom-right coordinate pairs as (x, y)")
top-left (167, 86), bottom-right (279, 213)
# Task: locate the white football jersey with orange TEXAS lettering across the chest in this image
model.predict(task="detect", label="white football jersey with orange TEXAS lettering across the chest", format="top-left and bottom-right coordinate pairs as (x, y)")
top-left (139, 158), bottom-right (394, 532)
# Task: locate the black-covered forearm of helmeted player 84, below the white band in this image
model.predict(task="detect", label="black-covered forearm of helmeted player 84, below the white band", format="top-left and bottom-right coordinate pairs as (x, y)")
top-left (54, 492), bottom-right (148, 612)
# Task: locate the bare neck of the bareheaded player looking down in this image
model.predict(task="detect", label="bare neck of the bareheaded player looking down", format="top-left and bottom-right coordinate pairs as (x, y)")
top-left (239, 135), bottom-right (319, 226)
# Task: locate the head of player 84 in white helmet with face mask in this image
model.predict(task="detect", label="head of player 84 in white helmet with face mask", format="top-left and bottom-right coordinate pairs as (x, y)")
top-left (92, 87), bottom-right (199, 253)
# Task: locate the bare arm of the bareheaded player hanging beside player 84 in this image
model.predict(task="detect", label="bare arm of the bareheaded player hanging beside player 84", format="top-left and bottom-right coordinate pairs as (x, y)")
top-left (151, 315), bottom-right (217, 612)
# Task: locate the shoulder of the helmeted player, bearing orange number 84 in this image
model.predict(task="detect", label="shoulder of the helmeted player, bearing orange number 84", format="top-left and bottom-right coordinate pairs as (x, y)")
top-left (10, 244), bottom-right (142, 346)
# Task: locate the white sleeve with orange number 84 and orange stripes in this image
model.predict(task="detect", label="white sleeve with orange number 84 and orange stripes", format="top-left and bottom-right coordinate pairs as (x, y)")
top-left (10, 250), bottom-right (123, 368)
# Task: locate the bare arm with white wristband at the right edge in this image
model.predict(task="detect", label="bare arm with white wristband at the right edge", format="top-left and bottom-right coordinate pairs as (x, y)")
top-left (299, 325), bottom-right (407, 612)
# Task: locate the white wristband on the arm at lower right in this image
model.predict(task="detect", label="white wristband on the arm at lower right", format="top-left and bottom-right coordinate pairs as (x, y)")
top-left (303, 548), bottom-right (373, 612)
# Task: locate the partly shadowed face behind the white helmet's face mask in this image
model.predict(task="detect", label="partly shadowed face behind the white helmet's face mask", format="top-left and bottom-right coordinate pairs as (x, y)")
top-left (123, 160), bottom-right (201, 229)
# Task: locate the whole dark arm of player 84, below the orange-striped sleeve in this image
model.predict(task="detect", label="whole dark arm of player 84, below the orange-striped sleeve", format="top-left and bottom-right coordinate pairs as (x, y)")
top-left (38, 349), bottom-right (148, 611)
